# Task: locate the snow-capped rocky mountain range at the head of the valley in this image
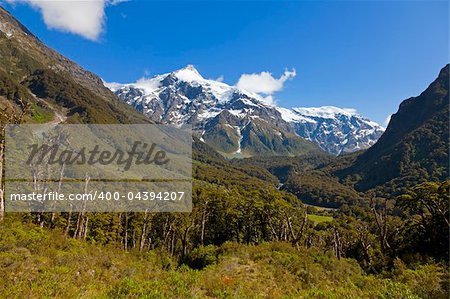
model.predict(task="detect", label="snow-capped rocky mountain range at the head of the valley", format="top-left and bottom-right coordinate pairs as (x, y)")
top-left (105, 65), bottom-right (384, 156)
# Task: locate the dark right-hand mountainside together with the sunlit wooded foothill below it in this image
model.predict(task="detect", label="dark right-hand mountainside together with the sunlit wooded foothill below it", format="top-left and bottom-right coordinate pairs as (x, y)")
top-left (235, 65), bottom-right (449, 207)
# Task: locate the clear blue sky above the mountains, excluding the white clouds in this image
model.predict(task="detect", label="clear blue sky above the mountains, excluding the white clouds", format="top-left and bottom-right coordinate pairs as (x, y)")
top-left (1, 0), bottom-right (449, 124)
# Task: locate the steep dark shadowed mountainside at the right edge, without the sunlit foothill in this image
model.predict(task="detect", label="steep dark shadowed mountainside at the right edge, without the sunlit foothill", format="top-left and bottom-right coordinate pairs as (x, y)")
top-left (333, 65), bottom-right (449, 194)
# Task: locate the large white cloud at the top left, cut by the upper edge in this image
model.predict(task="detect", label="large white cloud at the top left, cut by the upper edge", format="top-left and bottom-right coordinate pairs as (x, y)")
top-left (6, 0), bottom-right (125, 41)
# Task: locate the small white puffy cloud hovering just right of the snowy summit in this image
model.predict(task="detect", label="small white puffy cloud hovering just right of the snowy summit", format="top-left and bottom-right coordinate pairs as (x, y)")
top-left (236, 69), bottom-right (297, 104)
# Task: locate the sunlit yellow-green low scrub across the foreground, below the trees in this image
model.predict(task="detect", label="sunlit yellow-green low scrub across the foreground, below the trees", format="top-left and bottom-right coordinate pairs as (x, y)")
top-left (0, 219), bottom-right (445, 299)
